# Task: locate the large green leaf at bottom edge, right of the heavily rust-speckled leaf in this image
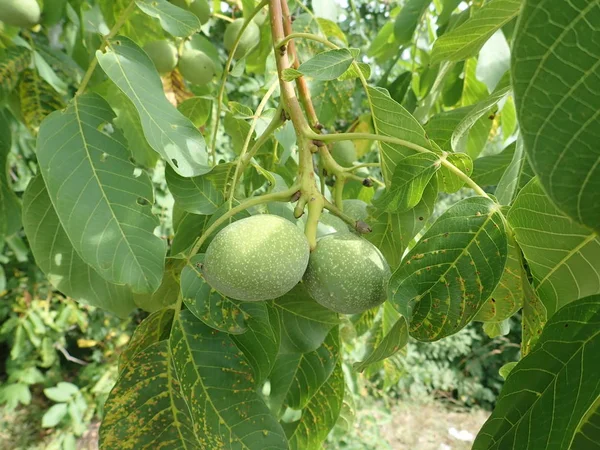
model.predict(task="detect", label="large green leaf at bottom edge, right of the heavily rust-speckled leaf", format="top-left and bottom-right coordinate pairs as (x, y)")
top-left (170, 311), bottom-right (288, 450)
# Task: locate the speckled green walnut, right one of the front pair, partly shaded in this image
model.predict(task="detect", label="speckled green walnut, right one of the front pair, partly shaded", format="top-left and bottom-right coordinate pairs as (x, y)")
top-left (304, 233), bottom-right (391, 314)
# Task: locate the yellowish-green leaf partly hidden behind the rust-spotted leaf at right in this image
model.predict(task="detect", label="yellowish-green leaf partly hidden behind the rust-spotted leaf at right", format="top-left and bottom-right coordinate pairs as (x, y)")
top-left (473, 232), bottom-right (527, 322)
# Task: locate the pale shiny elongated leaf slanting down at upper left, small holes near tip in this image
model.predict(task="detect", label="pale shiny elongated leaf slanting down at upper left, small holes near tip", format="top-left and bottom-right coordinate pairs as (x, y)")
top-left (96, 37), bottom-right (211, 177)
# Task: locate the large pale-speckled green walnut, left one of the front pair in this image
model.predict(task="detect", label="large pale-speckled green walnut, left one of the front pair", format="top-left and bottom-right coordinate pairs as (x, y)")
top-left (202, 214), bottom-right (310, 301)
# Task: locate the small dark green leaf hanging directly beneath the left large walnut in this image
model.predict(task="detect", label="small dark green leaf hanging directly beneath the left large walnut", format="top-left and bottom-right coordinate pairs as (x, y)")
top-left (231, 302), bottom-right (281, 388)
